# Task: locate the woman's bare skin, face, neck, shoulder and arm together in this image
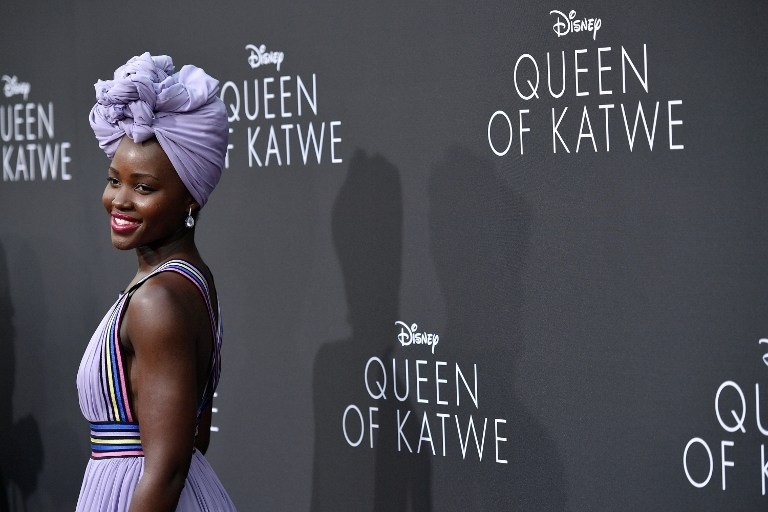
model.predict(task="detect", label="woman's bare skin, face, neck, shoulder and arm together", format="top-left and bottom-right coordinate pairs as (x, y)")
top-left (102, 137), bottom-right (217, 512)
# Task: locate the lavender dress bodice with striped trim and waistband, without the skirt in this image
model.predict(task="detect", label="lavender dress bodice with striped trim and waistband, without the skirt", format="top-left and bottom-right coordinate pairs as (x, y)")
top-left (77, 260), bottom-right (222, 458)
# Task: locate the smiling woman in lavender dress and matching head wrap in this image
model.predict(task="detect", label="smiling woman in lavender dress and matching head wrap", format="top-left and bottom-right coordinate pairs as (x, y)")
top-left (77, 53), bottom-right (234, 512)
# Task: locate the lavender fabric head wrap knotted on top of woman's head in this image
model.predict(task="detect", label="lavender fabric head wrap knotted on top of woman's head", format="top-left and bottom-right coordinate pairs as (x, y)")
top-left (90, 52), bottom-right (229, 208)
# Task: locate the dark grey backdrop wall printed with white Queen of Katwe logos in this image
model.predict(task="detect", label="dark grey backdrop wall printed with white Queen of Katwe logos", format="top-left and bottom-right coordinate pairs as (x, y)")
top-left (0, 0), bottom-right (768, 512)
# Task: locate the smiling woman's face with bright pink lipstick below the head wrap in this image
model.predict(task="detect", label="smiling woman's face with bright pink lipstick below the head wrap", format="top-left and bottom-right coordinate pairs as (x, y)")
top-left (102, 137), bottom-right (197, 250)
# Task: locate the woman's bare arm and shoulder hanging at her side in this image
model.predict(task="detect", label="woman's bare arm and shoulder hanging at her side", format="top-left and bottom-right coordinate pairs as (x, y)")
top-left (123, 272), bottom-right (210, 512)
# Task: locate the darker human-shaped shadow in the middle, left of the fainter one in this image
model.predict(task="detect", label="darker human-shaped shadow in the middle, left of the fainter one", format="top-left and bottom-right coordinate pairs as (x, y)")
top-left (311, 150), bottom-right (432, 512)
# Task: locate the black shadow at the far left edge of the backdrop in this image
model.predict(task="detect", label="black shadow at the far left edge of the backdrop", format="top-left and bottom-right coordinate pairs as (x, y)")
top-left (0, 244), bottom-right (43, 512)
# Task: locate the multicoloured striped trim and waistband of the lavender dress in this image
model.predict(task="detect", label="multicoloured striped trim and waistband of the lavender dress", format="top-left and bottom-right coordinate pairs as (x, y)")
top-left (91, 260), bottom-right (223, 458)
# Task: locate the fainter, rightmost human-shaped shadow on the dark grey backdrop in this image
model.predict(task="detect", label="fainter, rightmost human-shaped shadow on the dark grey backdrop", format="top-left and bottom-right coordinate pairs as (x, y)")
top-left (429, 146), bottom-right (567, 511)
